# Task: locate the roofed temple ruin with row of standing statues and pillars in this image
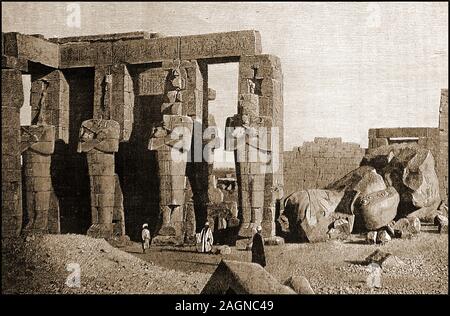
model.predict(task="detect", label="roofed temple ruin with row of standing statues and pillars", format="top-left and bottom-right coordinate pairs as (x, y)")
top-left (2, 31), bottom-right (283, 244)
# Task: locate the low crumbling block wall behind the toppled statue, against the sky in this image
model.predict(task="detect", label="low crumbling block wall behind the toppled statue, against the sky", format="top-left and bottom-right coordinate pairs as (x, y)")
top-left (284, 137), bottom-right (365, 196)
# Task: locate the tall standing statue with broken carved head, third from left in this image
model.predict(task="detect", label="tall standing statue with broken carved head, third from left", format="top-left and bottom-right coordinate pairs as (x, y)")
top-left (148, 61), bottom-right (196, 244)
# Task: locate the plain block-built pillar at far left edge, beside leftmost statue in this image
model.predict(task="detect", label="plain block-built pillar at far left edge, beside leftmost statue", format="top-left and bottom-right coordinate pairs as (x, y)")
top-left (2, 69), bottom-right (24, 238)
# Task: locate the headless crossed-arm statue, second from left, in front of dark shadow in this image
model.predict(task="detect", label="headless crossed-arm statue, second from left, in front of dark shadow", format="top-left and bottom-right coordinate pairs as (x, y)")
top-left (78, 119), bottom-right (120, 239)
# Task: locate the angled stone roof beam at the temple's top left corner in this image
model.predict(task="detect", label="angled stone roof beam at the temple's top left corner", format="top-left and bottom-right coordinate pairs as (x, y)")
top-left (2, 32), bottom-right (59, 68)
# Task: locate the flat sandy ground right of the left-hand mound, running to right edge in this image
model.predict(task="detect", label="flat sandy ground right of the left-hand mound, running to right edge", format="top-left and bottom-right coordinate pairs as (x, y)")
top-left (126, 226), bottom-right (448, 294)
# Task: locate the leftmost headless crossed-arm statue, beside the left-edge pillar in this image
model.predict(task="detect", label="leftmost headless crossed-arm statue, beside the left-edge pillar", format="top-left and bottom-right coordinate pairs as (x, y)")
top-left (21, 125), bottom-right (55, 233)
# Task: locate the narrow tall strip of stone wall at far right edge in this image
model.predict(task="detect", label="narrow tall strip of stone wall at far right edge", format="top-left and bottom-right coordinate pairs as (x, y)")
top-left (437, 89), bottom-right (448, 203)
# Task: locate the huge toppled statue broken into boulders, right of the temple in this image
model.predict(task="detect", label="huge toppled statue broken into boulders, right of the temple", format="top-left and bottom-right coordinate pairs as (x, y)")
top-left (278, 144), bottom-right (441, 242)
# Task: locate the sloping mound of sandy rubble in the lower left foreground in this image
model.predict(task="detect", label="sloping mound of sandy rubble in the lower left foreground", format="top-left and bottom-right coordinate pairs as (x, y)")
top-left (2, 234), bottom-right (209, 294)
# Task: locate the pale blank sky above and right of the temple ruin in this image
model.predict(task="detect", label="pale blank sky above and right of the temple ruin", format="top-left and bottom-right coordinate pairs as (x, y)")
top-left (2, 2), bottom-right (448, 158)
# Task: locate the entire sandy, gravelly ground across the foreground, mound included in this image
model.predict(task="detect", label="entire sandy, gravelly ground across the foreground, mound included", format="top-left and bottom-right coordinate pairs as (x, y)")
top-left (2, 226), bottom-right (448, 294)
